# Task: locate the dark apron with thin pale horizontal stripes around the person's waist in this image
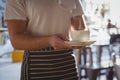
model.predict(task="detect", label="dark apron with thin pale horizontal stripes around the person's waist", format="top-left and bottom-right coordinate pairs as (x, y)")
top-left (21, 49), bottom-right (78, 80)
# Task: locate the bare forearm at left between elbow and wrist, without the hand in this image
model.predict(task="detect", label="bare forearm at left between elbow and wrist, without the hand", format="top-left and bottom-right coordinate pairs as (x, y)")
top-left (10, 34), bottom-right (49, 50)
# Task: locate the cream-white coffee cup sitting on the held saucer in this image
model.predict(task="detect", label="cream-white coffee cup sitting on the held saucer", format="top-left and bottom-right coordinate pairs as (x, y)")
top-left (69, 30), bottom-right (90, 42)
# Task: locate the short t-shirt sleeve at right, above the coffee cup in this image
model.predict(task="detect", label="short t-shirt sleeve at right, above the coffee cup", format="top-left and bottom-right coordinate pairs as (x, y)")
top-left (72, 0), bottom-right (84, 16)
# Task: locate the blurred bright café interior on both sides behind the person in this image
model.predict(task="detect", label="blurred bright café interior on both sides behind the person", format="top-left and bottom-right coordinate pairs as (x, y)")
top-left (0, 0), bottom-right (120, 80)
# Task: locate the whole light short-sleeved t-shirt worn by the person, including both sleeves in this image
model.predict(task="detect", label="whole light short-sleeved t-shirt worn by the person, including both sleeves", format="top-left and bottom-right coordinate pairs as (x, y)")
top-left (5, 0), bottom-right (83, 36)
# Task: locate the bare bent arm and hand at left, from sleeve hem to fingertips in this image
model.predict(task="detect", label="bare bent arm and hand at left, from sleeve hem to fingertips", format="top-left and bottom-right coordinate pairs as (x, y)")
top-left (6, 20), bottom-right (70, 50)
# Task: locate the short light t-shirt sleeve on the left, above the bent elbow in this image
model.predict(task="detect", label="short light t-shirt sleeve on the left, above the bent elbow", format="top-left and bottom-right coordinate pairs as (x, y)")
top-left (4, 0), bottom-right (26, 20)
